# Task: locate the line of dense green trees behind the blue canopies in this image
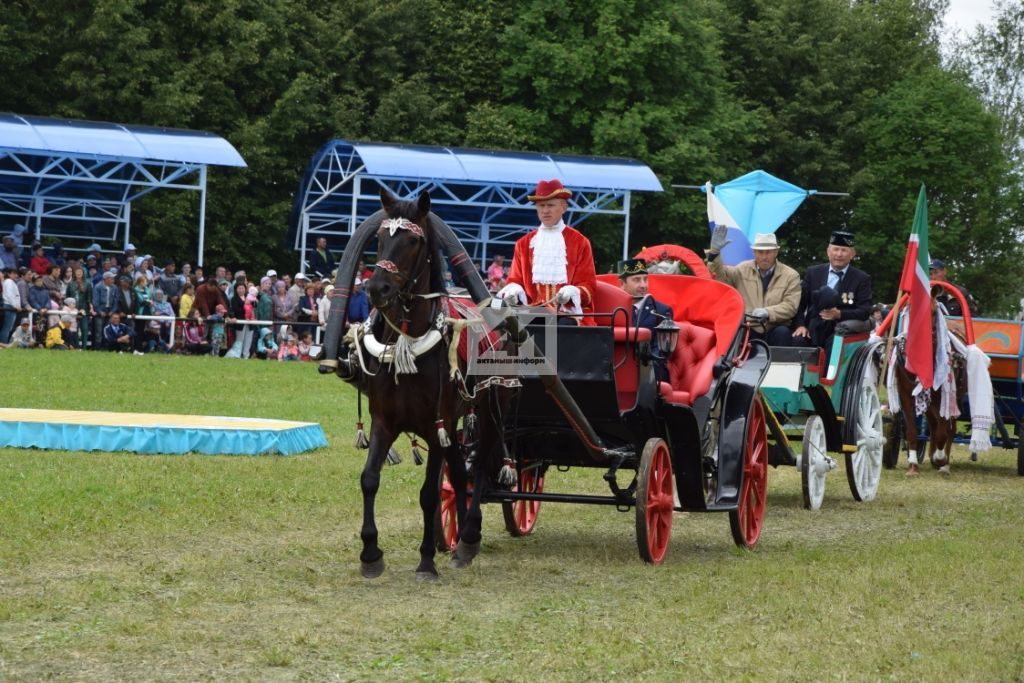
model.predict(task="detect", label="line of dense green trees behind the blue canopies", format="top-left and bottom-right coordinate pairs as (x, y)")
top-left (0, 0), bottom-right (1024, 314)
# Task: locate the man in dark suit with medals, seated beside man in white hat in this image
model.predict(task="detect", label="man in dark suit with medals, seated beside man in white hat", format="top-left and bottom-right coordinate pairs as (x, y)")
top-left (793, 230), bottom-right (871, 351)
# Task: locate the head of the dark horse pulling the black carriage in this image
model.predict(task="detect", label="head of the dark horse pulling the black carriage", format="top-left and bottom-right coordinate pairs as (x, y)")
top-left (366, 187), bottom-right (435, 309)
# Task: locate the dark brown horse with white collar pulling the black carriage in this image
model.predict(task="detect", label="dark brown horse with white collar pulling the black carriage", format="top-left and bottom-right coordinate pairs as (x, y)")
top-left (354, 189), bottom-right (502, 580)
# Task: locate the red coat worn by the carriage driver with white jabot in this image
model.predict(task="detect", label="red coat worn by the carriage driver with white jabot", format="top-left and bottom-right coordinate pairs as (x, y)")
top-left (508, 225), bottom-right (597, 325)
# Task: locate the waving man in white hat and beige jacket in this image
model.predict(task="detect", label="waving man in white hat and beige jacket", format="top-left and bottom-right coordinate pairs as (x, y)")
top-left (708, 226), bottom-right (801, 346)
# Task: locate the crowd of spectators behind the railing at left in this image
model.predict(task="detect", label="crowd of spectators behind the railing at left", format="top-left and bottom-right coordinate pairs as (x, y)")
top-left (0, 226), bottom-right (371, 361)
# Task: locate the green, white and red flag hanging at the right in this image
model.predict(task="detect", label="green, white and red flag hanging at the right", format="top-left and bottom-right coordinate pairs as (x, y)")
top-left (899, 185), bottom-right (935, 389)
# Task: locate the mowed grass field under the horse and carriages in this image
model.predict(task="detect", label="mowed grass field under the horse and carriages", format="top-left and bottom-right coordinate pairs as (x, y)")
top-left (0, 351), bottom-right (1024, 681)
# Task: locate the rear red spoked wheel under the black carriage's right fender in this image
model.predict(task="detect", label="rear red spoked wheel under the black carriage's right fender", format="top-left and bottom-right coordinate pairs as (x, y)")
top-left (729, 400), bottom-right (768, 548)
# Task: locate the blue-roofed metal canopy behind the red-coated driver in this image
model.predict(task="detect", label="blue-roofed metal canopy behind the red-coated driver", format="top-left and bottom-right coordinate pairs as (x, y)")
top-left (290, 139), bottom-right (662, 269)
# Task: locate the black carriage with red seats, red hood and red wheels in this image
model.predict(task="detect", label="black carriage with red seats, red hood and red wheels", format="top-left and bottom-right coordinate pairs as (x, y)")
top-left (438, 274), bottom-right (769, 564)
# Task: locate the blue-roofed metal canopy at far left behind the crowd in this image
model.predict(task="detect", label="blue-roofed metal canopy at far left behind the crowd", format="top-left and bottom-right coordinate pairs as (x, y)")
top-left (0, 114), bottom-right (246, 265)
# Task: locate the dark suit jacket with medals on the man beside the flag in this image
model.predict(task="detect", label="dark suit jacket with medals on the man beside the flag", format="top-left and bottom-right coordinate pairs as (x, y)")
top-left (793, 263), bottom-right (872, 347)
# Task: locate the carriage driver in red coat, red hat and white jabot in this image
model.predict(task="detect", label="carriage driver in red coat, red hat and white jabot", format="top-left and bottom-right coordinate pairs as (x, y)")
top-left (496, 178), bottom-right (597, 325)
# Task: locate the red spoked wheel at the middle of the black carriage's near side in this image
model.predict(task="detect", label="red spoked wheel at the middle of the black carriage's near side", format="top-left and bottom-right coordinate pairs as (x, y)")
top-left (636, 438), bottom-right (674, 564)
